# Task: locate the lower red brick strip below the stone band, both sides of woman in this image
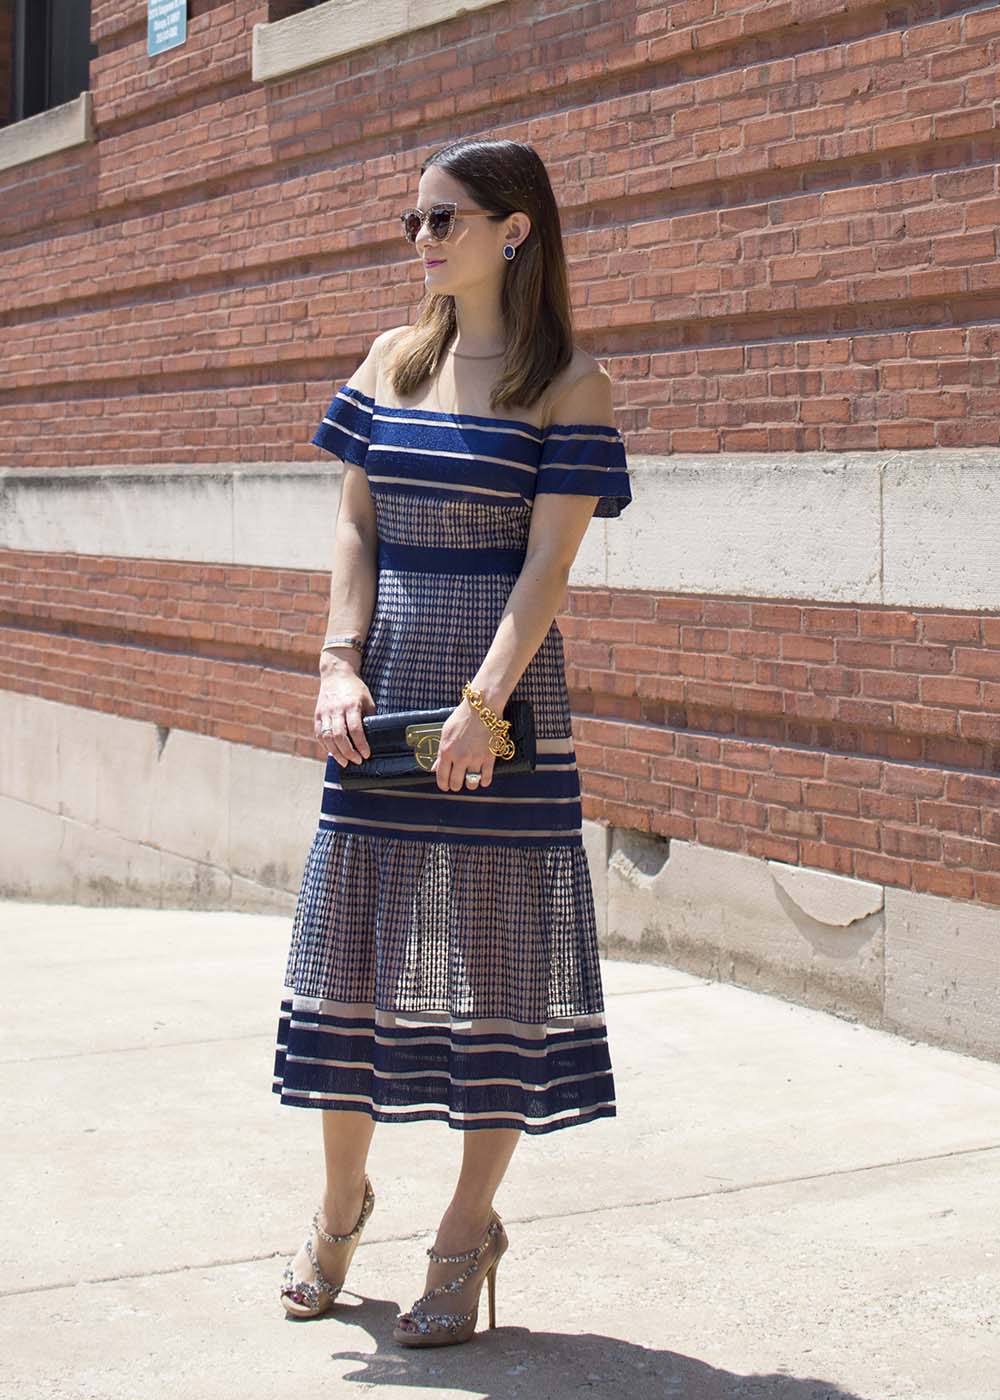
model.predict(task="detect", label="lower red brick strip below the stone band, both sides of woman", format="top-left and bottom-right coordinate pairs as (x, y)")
top-left (0, 552), bottom-right (1000, 904)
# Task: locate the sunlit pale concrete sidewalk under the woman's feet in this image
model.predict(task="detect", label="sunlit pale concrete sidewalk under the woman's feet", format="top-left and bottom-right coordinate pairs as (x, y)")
top-left (0, 903), bottom-right (1000, 1400)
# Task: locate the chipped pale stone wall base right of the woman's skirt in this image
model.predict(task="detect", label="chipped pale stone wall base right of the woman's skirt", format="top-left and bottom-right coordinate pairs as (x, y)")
top-left (599, 822), bottom-right (1000, 1061)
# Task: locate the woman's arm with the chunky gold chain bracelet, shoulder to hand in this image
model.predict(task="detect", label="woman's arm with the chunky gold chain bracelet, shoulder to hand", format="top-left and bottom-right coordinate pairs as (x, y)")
top-left (431, 368), bottom-right (615, 792)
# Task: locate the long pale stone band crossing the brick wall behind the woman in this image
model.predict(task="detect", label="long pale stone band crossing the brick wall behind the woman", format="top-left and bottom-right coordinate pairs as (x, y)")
top-left (0, 449), bottom-right (1000, 612)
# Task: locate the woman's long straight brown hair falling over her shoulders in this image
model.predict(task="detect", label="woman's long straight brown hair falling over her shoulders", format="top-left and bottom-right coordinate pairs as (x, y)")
top-left (380, 137), bottom-right (573, 409)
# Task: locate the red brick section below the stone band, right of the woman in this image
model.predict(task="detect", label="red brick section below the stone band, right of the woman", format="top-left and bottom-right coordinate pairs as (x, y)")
top-left (560, 589), bottom-right (1000, 904)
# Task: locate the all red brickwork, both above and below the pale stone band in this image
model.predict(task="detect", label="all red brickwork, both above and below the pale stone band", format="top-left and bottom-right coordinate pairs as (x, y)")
top-left (0, 0), bottom-right (1000, 903)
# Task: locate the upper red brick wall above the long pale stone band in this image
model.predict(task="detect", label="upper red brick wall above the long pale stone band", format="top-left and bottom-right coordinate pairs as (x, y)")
top-left (0, 0), bottom-right (1000, 465)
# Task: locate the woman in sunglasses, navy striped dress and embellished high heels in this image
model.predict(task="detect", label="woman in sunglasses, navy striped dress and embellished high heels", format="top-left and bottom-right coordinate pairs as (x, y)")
top-left (273, 140), bottom-right (632, 1345)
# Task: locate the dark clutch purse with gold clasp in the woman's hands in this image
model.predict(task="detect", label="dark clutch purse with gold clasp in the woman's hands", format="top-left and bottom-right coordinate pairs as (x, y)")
top-left (333, 700), bottom-right (535, 791)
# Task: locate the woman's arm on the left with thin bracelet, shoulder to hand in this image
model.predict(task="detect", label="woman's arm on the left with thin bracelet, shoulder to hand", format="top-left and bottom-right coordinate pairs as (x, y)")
top-left (314, 332), bottom-right (389, 764)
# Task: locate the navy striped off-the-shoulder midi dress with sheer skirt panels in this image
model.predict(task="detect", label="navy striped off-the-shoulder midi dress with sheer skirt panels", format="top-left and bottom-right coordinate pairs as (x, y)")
top-left (273, 384), bottom-right (632, 1133)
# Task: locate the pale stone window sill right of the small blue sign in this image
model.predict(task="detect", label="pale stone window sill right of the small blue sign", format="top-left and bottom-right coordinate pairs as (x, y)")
top-left (251, 0), bottom-right (500, 83)
